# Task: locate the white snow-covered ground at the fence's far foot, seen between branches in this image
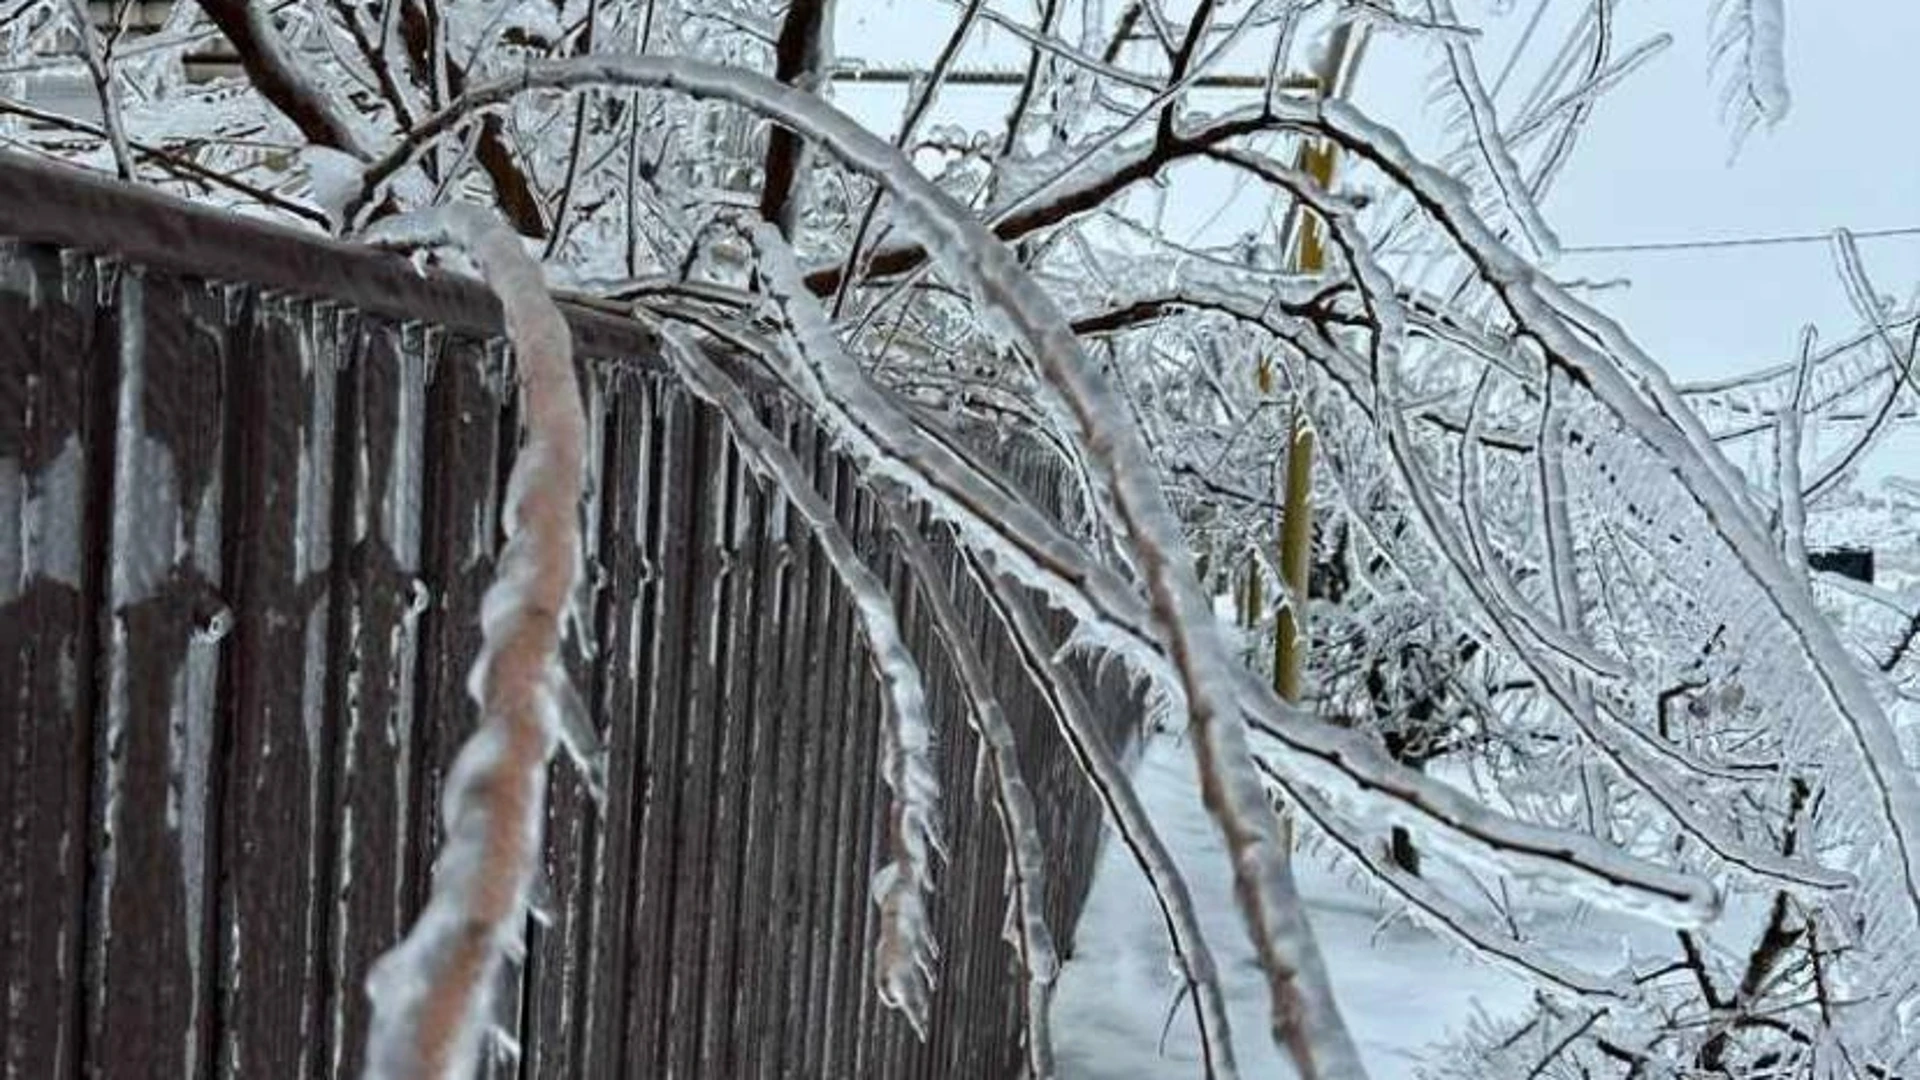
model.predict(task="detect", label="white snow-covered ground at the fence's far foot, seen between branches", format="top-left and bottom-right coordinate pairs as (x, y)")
top-left (1054, 736), bottom-right (1659, 1080)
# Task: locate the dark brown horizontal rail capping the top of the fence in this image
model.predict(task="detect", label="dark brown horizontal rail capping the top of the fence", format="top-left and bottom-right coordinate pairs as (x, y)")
top-left (0, 152), bottom-right (657, 369)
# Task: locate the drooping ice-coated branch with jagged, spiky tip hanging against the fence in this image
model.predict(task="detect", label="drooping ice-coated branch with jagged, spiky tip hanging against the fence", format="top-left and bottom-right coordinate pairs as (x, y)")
top-left (660, 323), bottom-right (939, 1040)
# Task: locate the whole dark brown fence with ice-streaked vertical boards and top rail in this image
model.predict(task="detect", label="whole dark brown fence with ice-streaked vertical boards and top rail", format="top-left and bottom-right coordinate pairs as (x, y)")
top-left (0, 158), bottom-right (1139, 1080)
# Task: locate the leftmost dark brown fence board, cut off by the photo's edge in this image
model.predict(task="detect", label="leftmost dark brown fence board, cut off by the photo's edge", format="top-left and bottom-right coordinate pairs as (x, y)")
top-left (0, 244), bottom-right (100, 1078)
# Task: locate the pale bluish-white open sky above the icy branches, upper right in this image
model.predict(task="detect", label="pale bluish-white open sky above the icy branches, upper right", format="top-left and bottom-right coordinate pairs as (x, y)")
top-left (1357, 0), bottom-right (1920, 379)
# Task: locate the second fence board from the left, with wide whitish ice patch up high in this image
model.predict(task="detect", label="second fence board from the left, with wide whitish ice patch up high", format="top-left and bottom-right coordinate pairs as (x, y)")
top-left (86, 267), bottom-right (227, 1078)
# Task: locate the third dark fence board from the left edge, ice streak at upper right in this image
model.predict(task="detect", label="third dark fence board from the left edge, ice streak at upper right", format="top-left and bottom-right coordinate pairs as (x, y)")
top-left (217, 290), bottom-right (338, 1078)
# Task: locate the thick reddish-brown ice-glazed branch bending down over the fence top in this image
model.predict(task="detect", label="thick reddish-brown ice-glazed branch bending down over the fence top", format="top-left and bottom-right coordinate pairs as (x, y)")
top-left (351, 206), bottom-right (586, 1080)
